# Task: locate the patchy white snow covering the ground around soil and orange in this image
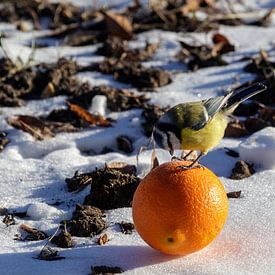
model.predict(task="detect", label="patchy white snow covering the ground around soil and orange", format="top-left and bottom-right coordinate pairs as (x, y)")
top-left (0, 0), bottom-right (275, 275)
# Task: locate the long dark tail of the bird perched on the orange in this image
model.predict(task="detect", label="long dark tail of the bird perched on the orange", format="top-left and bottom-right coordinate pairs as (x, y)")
top-left (223, 81), bottom-right (267, 113)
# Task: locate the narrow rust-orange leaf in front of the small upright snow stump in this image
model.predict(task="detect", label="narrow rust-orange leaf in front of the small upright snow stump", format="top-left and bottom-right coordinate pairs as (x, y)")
top-left (68, 103), bottom-right (111, 127)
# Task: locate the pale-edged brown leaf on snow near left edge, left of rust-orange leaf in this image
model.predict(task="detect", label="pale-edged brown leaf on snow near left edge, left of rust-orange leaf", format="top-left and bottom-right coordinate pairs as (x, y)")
top-left (7, 115), bottom-right (54, 140)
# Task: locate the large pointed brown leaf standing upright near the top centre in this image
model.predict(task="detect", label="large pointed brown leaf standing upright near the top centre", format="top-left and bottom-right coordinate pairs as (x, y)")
top-left (102, 11), bottom-right (133, 40)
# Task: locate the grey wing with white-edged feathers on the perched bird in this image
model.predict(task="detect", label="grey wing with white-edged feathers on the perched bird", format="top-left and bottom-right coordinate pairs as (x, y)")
top-left (192, 91), bottom-right (233, 131)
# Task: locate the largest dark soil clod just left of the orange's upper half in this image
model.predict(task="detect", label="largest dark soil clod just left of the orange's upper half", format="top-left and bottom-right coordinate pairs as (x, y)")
top-left (84, 167), bottom-right (140, 209)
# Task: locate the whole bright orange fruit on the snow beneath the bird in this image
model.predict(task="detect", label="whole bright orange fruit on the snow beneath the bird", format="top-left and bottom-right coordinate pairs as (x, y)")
top-left (132, 161), bottom-right (228, 255)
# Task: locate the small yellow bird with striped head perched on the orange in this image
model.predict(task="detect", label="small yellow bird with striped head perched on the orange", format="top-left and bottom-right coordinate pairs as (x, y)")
top-left (151, 81), bottom-right (267, 169)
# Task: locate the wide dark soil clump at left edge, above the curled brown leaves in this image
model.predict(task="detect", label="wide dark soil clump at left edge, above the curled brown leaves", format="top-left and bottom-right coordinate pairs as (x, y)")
top-left (0, 58), bottom-right (90, 107)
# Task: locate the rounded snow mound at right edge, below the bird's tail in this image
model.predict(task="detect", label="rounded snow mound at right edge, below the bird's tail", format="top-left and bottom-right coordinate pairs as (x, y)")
top-left (239, 127), bottom-right (275, 170)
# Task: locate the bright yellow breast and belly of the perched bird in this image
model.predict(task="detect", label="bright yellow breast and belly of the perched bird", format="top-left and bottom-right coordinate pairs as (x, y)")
top-left (181, 113), bottom-right (228, 152)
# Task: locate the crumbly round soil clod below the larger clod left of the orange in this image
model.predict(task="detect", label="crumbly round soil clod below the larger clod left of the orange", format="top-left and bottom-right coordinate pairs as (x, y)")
top-left (67, 204), bottom-right (107, 237)
